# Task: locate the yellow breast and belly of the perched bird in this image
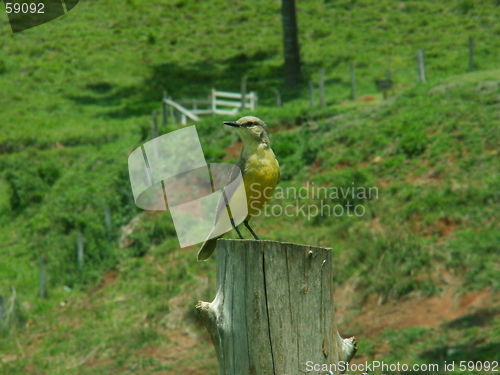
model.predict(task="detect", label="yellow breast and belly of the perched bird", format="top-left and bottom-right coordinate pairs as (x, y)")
top-left (243, 147), bottom-right (280, 220)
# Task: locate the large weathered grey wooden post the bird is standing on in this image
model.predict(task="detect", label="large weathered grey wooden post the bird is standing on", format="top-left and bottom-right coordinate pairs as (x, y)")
top-left (196, 239), bottom-right (356, 375)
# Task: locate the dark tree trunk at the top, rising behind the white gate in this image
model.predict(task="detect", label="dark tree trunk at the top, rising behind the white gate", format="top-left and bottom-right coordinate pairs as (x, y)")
top-left (281, 0), bottom-right (301, 87)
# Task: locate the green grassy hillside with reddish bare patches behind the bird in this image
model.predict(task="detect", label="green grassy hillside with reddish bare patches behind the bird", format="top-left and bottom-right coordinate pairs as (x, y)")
top-left (0, 0), bottom-right (500, 374)
